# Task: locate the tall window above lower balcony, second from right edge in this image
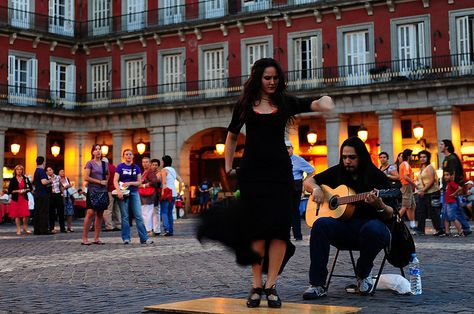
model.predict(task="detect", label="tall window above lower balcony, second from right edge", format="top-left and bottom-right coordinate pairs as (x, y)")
top-left (391, 15), bottom-right (431, 79)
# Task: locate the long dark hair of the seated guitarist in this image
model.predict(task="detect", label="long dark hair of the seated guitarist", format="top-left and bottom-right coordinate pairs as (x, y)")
top-left (339, 136), bottom-right (380, 188)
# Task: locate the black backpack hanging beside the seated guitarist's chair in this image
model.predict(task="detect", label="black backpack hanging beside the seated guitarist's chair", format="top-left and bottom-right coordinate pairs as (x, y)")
top-left (385, 213), bottom-right (416, 268)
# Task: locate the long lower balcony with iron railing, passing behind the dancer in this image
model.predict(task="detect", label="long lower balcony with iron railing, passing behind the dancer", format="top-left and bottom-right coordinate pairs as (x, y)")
top-left (0, 53), bottom-right (474, 110)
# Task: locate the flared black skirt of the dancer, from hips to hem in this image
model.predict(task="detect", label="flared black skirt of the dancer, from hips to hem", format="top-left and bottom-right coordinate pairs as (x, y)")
top-left (197, 182), bottom-right (295, 273)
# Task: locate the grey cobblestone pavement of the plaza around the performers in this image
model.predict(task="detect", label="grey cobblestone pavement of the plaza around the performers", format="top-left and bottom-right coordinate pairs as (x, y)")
top-left (0, 218), bottom-right (474, 313)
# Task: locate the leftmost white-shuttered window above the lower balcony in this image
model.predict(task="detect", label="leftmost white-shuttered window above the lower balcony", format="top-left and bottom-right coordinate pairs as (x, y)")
top-left (8, 55), bottom-right (38, 105)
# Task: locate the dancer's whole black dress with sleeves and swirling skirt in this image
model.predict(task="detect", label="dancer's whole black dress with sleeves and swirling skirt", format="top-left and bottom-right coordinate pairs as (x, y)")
top-left (198, 96), bottom-right (312, 271)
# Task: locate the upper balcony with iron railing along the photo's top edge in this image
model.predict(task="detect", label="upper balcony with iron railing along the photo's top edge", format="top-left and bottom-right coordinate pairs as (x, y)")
top-left (0, 0), bottom-right (340, 41)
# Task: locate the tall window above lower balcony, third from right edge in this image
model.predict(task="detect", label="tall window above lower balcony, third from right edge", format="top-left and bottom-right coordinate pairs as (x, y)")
top-left (337, 24), bottom-right (374, 85)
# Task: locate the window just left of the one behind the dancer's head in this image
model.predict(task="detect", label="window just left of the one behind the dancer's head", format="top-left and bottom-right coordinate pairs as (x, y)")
top-left (199, 43), bottom-right (228, 97)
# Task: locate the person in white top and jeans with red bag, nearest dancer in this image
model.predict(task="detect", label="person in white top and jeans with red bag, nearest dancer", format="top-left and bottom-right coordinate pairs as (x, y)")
top-left (160, 155), bottom-right (184, 237)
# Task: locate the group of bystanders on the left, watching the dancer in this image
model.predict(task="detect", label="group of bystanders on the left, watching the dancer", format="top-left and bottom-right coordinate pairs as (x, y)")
top-left (0, 144), bottom-right (184, 245)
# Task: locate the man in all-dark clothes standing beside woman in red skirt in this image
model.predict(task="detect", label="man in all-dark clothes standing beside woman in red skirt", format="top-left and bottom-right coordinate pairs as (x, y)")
top-left (33, 156), bottom-right (51, 235)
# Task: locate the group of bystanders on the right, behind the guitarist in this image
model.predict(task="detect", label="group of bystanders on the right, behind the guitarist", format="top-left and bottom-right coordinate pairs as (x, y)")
top-left (379, 139), bottom-right (474, 237)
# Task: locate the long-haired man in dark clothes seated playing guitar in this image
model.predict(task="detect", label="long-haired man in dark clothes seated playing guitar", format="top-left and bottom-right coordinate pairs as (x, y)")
top-left (303, 137), bottom-right (394, 300)
